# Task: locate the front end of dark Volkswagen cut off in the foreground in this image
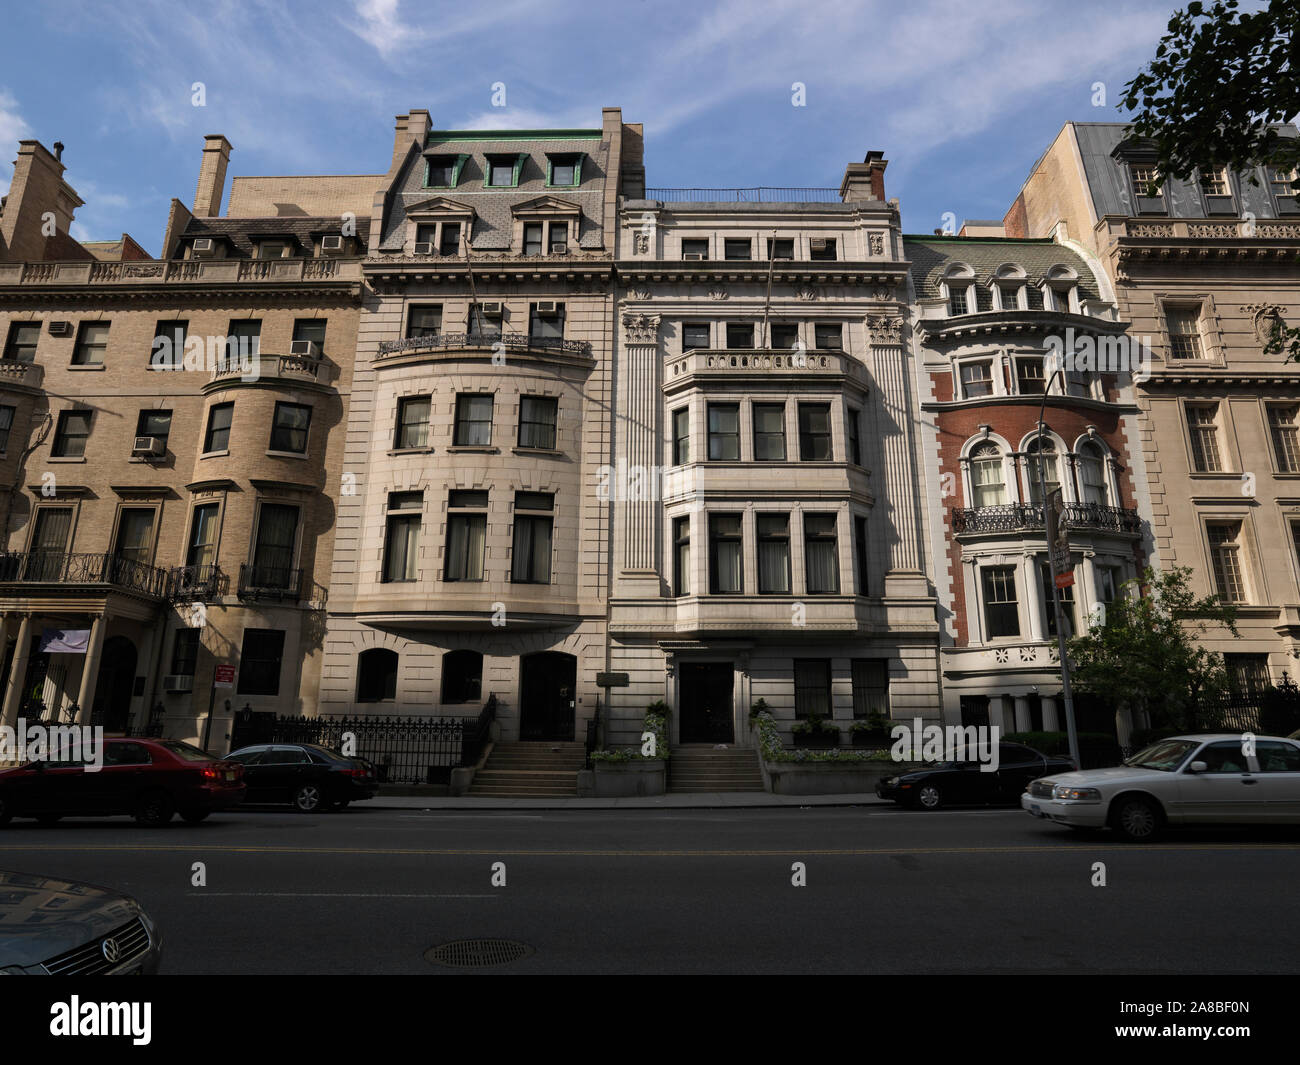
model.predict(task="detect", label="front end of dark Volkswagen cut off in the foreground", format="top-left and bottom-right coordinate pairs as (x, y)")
top-left (0, 870), bottom-right (163, 977)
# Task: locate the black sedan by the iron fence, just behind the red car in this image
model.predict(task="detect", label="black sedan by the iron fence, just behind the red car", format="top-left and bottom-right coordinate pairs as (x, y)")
top-left (226, 744), bottom-right (380, 814)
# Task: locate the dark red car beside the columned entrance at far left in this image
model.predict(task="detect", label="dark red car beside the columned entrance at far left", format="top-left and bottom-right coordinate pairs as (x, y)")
top-left (0, 737), bottom-right (246, 824)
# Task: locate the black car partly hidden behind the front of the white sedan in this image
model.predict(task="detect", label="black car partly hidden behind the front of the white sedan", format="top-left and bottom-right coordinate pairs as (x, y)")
top-left (876, 744), bottom-right (1075, 810)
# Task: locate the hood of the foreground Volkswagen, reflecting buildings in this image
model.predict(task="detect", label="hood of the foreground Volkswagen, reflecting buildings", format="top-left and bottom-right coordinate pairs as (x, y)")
top-left (0, 870), bottom-right (140, 969)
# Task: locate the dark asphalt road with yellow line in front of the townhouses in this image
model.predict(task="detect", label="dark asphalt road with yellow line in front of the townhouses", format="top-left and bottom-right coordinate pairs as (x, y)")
top-left (0, 804), bottom-right (1300, 974)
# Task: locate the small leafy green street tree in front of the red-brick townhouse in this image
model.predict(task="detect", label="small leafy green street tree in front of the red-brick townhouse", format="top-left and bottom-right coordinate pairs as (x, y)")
top-left (1067, 566), bottom-right (1238, 728)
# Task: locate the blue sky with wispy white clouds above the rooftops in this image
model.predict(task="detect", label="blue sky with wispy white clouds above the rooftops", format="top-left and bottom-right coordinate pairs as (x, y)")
top-left (0, 0), bottom-right (1175, 254)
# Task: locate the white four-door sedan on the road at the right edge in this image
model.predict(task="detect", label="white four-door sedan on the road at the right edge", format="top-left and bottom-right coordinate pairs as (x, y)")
top-left (1021, 732), bottom-right (1300, 843)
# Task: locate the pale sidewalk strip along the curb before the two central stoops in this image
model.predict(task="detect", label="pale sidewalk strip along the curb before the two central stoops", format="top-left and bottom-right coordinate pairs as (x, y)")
top-left (366, 792), bottom-right (894, 810)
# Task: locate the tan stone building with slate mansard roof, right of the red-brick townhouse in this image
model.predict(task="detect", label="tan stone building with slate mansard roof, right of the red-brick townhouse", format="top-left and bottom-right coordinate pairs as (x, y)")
top-left (1005, 122), bottom-right (1300, 690)
